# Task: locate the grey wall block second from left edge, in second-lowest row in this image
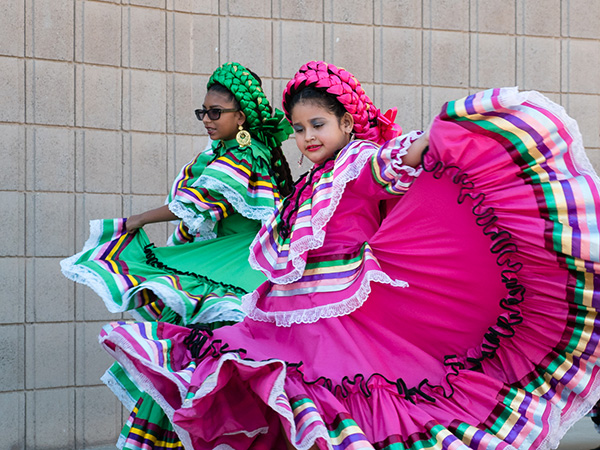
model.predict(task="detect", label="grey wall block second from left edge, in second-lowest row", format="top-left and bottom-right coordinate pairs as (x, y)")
top-left (25, 323), bottom-right (75, 389)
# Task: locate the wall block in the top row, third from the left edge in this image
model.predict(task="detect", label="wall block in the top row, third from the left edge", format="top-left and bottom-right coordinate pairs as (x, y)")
top-left (75, 2), bottom-right (122, 66)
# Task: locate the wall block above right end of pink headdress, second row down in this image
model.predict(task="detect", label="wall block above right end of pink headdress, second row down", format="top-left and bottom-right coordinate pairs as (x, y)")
top-left (374, 28), bottom-right (423, 84)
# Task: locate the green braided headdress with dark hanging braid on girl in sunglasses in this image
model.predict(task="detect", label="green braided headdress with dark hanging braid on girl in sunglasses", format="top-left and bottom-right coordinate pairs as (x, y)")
top-left (206, 62), bottom-right (293, 197)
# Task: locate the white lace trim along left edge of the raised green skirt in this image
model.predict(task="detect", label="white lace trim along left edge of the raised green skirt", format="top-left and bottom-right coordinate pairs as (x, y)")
top-left (60, 220), bottom-right (125, 313)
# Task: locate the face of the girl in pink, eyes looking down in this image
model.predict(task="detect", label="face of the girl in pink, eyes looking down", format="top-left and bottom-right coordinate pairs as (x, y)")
top-left (292, 101), bottom-right (354, 164)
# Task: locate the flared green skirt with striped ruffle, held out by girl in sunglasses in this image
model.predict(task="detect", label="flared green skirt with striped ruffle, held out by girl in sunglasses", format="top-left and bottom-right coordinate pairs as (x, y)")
top-left (61, 219), bottom-right (264, 324)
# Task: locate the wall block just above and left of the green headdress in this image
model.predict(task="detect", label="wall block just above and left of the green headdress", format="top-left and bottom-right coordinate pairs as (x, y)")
top-left (167, 13), bottom-right (219, 74)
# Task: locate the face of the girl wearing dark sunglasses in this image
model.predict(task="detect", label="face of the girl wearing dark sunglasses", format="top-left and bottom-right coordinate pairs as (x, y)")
top-left (202, 90), bottom-right (246, 141)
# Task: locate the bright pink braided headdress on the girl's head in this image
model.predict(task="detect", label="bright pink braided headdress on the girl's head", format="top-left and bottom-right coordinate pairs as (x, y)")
top-left (283, 61), bottom-right (402, 144)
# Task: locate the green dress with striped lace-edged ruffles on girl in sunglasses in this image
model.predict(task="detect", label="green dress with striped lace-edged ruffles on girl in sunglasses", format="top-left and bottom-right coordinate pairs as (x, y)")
top-left (61, 139), bottom-right (279, 449)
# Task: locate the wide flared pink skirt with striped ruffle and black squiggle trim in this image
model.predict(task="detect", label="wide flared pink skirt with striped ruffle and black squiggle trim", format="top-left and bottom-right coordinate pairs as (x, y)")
top-left (100, 90), bottom-right (600, 450)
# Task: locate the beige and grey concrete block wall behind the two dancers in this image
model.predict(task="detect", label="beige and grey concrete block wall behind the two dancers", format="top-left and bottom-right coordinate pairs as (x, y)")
top-left (0, 0), bottom-right (600, 449)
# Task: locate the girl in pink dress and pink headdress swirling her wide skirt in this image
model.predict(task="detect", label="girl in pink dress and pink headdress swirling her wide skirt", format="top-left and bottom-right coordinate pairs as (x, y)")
top-left (100, 61), bottom-right (600, 450)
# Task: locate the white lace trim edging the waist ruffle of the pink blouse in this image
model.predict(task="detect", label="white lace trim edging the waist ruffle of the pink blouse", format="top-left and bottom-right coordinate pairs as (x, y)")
top-left (242, 269), bottom-right (408, 327)
